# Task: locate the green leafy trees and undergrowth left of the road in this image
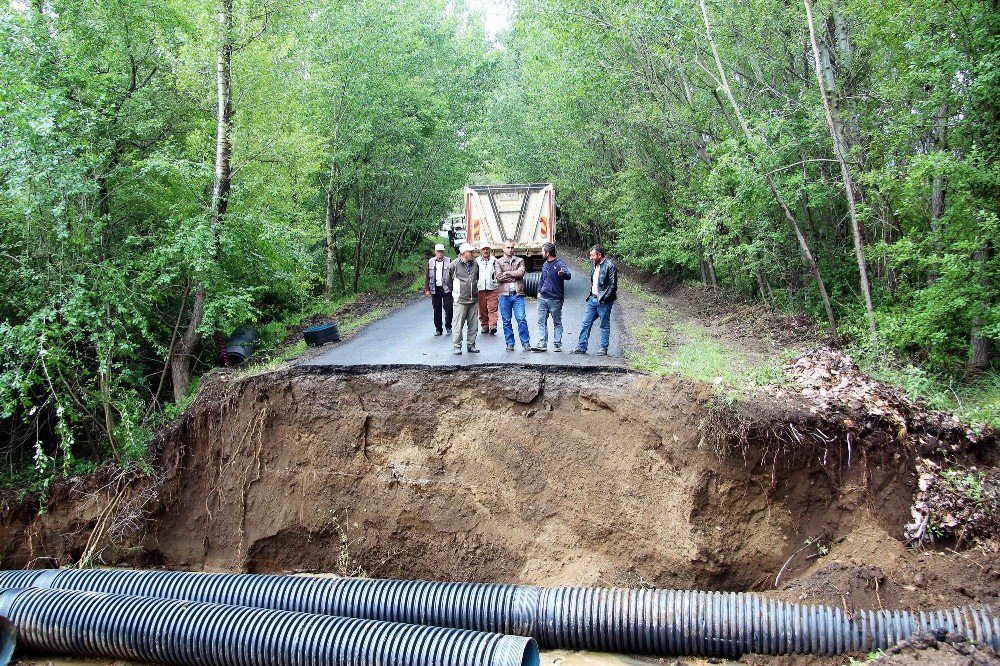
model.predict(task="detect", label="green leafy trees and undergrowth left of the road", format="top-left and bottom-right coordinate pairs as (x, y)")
top-left (0, 0), bottom-right (488, 488)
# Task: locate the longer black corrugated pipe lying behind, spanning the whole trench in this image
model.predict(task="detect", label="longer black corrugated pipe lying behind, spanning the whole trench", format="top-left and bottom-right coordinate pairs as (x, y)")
top-left (0, 569), bottom-right (1000, 657)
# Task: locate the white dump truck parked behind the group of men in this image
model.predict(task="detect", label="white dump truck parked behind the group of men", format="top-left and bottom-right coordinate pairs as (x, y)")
top-left (465, 183), bottom-right (556, 280)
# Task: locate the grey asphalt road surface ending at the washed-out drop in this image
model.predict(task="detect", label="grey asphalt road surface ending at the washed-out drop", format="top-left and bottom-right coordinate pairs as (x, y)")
top-left (303, 255), bottom-right (625, 366)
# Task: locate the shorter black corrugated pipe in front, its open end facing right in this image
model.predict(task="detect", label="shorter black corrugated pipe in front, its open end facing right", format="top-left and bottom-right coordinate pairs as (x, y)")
top-left (0, 588), bottom-right (538, 666)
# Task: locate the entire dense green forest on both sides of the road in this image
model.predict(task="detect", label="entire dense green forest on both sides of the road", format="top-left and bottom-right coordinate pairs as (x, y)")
top-left (0, 0), bottom-right (1000, 482)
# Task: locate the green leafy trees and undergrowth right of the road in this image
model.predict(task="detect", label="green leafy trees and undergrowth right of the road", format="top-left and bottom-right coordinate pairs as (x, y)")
top-left (483, 0), bottom-right (1000, 373)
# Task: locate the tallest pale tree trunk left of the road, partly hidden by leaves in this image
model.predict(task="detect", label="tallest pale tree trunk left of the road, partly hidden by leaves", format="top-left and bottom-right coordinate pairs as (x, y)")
top-left (171, 0), bottom-right (233, 402)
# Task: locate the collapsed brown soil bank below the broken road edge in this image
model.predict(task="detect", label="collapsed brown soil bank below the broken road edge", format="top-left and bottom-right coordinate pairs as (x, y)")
top-left (0, 366), bottom-right (997, 606)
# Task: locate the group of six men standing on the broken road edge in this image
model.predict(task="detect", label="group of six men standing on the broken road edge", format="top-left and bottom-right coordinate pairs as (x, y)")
top-left (424, 241), bottom-right (618, 356)
